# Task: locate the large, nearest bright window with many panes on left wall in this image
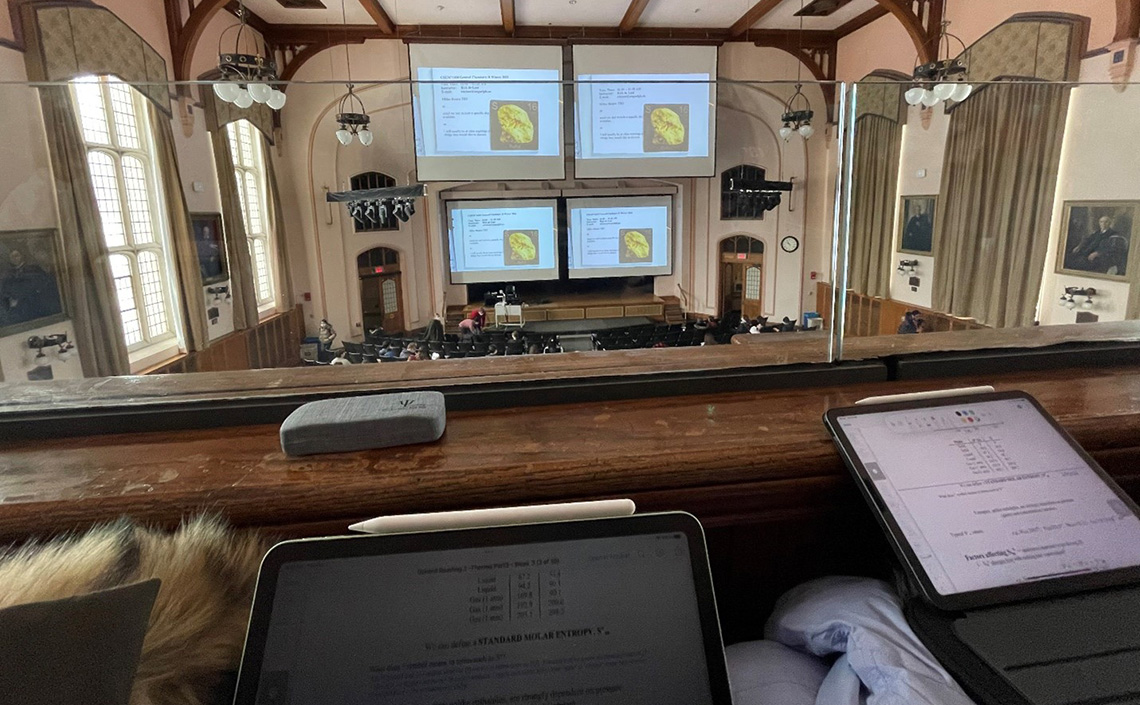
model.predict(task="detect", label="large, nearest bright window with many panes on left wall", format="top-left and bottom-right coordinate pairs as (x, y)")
top-left (72, 76), bottom-right (176, 351)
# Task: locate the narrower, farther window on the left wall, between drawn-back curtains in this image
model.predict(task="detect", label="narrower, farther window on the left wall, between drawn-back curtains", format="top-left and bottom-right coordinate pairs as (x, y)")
top-left (226, 120), bottom-right (274, 307)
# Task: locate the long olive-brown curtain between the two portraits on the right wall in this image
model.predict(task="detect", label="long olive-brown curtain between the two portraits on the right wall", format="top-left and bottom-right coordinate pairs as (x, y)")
top-left (934, 83), bottom-right (1069, 327)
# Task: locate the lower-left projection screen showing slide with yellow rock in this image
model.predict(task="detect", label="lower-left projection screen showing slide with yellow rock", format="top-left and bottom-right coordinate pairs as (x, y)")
top-left (447, 200), bottom-right (559, 284)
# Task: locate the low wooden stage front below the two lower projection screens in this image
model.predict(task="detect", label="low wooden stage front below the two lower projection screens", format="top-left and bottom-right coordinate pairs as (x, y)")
top-left (447, 293), bottom-right (684, 332)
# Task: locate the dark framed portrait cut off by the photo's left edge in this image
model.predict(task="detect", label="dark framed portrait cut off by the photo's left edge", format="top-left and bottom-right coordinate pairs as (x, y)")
top-left (0, 224), bottom-right (67, 338)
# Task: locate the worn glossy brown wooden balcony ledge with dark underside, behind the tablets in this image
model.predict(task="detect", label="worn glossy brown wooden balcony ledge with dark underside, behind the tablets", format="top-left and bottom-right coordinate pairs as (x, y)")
top-left (0, 365), bottom-right (1140, 642)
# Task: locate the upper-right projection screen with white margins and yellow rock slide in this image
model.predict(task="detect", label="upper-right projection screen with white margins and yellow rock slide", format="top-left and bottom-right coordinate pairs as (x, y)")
top-left (575, 47), bottom-right (716, 178)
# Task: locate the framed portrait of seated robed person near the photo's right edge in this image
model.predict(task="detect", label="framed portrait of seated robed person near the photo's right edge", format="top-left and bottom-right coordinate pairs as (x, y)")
top-left (1057, 201), bottom-right (1140, 282)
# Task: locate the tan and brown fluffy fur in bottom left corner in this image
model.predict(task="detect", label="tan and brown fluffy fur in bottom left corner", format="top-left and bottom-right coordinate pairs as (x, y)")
top-left (0, 517), bottom-right (271, 705)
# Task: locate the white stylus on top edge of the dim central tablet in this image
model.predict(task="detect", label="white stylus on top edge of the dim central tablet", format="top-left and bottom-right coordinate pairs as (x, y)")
top-left (349, 500), bottom-right (637, 534)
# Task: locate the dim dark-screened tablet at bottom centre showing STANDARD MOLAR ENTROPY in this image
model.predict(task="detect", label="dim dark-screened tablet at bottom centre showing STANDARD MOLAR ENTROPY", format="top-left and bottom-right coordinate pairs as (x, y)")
top-left (234, 513), bottom-right (731, 705)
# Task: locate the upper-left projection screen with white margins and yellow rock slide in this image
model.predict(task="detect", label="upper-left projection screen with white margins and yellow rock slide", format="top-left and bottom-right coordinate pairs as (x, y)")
top-left (408, 44), bottom-right (564, 181)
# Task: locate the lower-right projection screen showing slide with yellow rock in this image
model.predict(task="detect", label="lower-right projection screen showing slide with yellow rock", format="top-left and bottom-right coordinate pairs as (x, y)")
top-left (567, 196), bottom-right (673, 279)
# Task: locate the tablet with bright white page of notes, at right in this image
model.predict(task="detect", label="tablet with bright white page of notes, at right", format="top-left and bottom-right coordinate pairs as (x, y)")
top-left (824, 391), bottom-right (1140, 609)
